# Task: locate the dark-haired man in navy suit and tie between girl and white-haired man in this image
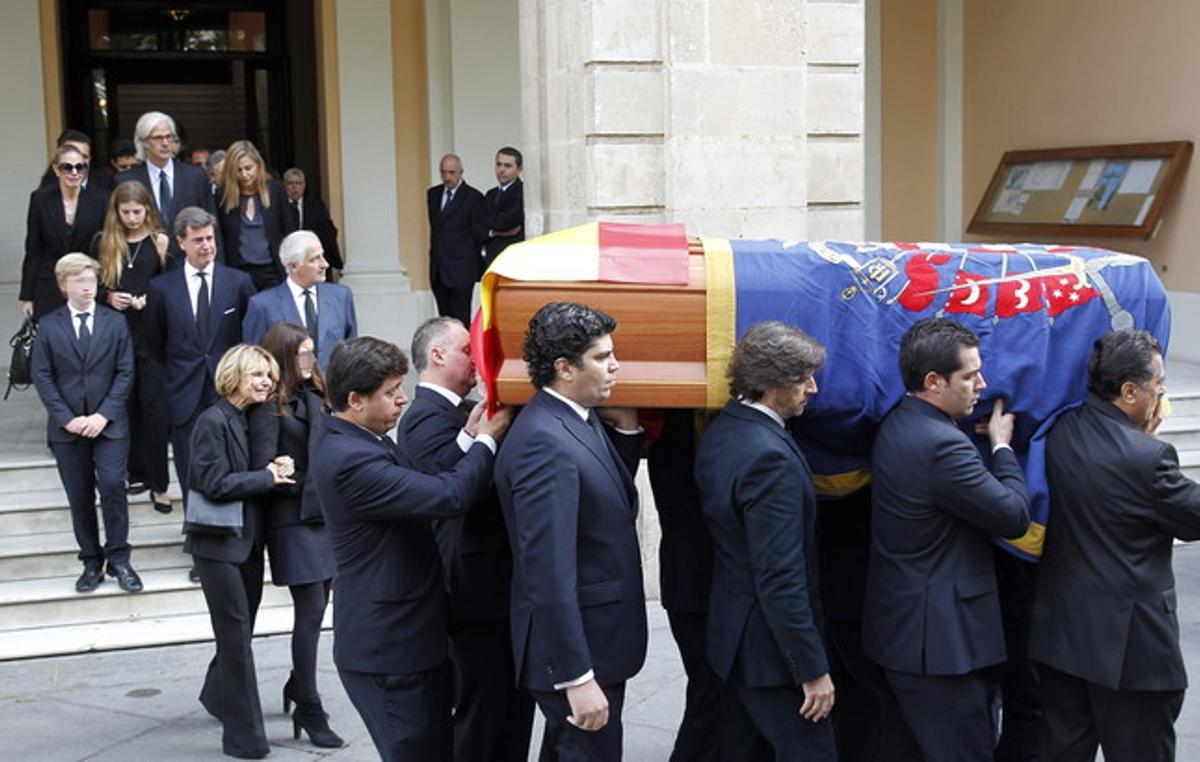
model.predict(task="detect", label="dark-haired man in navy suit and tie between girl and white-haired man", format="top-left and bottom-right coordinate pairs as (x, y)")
top-left (144, 205), bottom-right (254, 582)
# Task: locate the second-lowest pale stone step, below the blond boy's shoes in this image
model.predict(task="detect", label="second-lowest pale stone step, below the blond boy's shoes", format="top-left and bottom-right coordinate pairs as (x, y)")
top-left (0, 565), bottom-right (292, 630)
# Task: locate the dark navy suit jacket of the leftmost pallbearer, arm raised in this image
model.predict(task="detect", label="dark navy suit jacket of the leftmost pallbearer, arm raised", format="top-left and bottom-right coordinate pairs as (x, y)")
top-left (310, 415), bottom-right (493, 674)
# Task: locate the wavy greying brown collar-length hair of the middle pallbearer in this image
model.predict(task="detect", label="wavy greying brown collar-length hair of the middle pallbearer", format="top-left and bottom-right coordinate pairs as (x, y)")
top-left (725, 320), bottom-right (826, 402)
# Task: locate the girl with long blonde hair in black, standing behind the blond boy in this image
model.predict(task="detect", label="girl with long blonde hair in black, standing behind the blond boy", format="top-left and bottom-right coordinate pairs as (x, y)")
top-left (91, 181), bottom-right (170, 514)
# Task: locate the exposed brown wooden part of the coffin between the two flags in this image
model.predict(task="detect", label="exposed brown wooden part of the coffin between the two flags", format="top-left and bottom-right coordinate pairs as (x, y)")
top-left (494, 247), bottom-right (707, 408)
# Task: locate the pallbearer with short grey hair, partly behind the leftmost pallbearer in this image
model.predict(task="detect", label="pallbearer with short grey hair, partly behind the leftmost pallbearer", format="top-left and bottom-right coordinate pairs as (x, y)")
top-left (398, 317), bottom-right (533, 762)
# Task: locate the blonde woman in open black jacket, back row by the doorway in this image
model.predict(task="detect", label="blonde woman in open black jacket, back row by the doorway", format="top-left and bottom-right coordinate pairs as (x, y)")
top-left (221, 140), bottom-right (287, 290)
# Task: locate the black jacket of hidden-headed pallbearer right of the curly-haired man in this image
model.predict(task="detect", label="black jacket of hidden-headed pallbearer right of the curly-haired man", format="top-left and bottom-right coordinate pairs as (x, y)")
top-left (646, 410), bottom-right (713, 613)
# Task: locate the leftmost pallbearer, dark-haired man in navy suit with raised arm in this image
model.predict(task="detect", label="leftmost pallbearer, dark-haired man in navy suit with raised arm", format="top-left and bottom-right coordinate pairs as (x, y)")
top-left (312, 336), bottom-right (511, 760)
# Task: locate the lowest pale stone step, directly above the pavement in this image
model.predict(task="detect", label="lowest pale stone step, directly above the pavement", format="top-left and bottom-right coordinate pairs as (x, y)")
top-left (0, 602), bottom-right (332, 660)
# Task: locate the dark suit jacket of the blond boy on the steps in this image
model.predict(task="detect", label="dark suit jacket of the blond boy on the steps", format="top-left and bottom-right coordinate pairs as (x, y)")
top-left (32, 305), bottom-right (133, 442)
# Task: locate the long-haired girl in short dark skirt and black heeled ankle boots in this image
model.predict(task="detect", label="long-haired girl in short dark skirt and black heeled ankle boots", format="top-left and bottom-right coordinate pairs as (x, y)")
top-left (250, 323), bottom-right (342, 748)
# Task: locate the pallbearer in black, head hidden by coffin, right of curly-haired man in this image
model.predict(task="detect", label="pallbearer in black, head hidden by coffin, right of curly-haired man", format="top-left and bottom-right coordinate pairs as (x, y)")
top-left (646, 410), bottom-right (724, 762)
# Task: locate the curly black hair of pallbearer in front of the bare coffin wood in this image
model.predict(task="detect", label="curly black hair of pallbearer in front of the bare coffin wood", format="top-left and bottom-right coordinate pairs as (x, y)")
top-left (523, 301), bottom-right (617, 389)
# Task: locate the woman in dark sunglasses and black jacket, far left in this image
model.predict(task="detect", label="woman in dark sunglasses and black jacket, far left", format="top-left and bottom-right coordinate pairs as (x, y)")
top-left (18, 144), bottom-right (108, 319)
